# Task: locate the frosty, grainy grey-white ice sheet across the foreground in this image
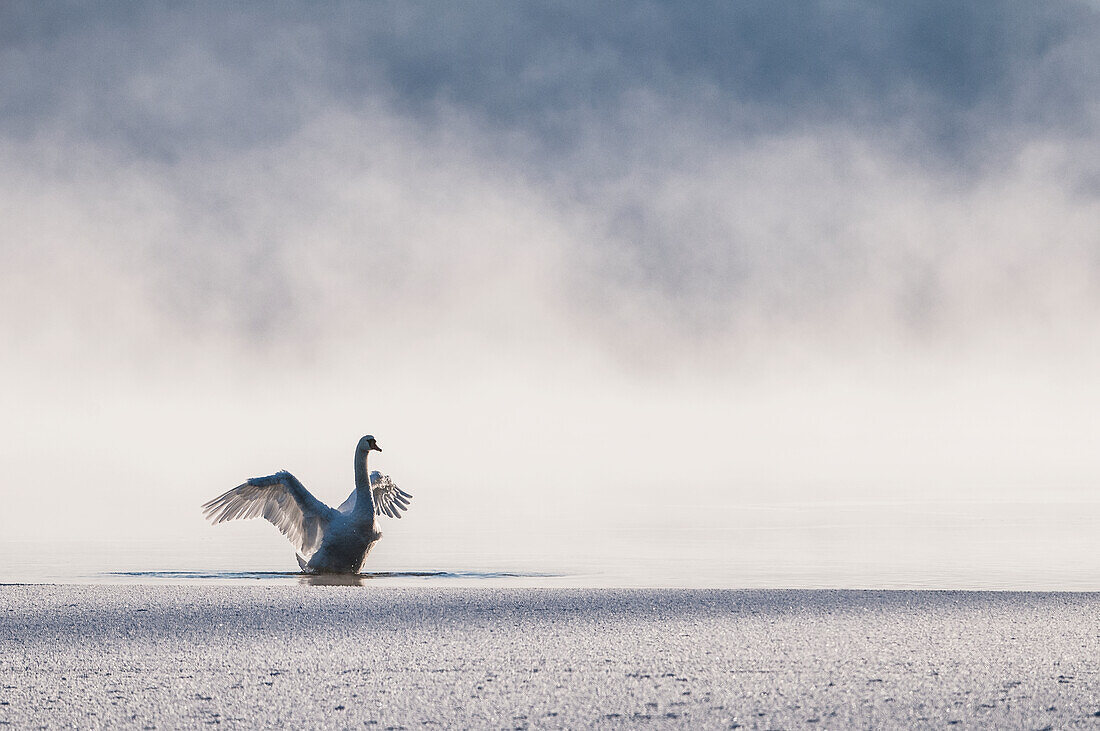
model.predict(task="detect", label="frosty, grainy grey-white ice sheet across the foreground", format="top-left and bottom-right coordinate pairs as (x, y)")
top-left (0, 586), bottom-right (1100, 729)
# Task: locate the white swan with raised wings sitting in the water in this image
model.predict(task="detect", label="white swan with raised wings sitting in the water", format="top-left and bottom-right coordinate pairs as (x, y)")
top-left (202, 434), bottom-right (413, 574)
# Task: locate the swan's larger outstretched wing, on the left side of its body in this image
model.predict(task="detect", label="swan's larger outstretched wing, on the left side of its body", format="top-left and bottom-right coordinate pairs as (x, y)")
top-left (202, 470), bottom-right (336, 557)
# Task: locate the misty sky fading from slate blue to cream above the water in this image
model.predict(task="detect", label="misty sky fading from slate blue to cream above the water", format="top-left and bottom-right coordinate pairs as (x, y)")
top-left (0, 0), bottom-right (1100, 547)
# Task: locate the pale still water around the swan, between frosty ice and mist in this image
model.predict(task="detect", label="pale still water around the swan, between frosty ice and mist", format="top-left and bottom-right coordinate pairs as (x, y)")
top-left (0, 502), bottom-right (1100, 590)
